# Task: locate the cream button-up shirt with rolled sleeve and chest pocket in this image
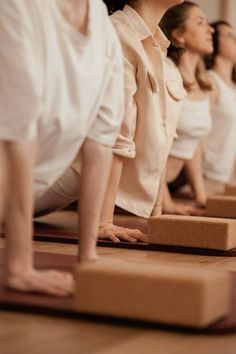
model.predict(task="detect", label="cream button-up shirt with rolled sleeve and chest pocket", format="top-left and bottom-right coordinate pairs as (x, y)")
top-left (109, 6), bottom-right (185, 217)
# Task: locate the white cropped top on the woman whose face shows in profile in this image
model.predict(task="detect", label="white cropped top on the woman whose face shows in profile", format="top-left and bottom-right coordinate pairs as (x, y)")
top-left (170, 95), bottom-right (212, 160)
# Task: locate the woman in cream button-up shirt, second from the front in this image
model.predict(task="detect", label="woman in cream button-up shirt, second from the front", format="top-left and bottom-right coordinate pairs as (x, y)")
top-left (97, 0), bottom-right (185, 242)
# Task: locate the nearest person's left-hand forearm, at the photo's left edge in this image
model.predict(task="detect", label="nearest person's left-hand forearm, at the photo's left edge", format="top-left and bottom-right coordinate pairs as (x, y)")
top-left (3, 141), bottom-right (36, 274)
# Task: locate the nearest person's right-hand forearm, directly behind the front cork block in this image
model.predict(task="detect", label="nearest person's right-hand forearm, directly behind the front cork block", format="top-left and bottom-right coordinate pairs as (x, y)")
top-left (79, 139), bottom-right (112, 261)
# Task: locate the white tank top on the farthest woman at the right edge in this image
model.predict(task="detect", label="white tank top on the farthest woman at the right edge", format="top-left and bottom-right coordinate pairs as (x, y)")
top-left (203, 71), bottom-right (236, 183)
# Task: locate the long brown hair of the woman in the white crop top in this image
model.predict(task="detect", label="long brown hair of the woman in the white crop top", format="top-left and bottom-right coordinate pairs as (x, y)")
top-left (160, 1), bottom-right (212, 91)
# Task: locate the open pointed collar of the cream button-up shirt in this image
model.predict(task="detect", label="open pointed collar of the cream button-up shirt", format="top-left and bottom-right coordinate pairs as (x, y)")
top-left (123, 5), bottom-right (170, 52)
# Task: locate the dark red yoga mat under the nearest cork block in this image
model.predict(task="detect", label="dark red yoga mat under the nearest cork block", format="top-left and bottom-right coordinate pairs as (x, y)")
top-left (0, 249), bottom-right (236, 334)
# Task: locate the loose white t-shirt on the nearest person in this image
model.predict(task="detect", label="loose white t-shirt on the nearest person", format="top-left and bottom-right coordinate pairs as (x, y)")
top-left (0, 0), bottom-right (124, 200)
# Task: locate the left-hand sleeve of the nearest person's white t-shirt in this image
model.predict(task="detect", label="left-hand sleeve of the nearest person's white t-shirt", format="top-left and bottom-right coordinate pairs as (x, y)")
top-left (0, 0), bottom-right (41, 142)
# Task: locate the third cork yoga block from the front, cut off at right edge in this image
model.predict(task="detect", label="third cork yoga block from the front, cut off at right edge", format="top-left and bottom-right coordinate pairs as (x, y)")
top-left (206, 196), bottom-right (236, 219)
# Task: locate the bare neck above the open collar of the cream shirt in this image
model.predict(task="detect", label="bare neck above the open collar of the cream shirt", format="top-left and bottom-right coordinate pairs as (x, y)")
top-left (133, 1), bottom-right (167, 34)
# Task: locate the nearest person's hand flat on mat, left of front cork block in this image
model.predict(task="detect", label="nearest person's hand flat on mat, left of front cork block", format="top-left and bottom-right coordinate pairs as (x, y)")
top-left (5, 269), bottom-right (74, 297)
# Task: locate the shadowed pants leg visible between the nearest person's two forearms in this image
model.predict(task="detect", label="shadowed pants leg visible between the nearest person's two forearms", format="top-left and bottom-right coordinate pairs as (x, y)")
top-left (34, 167), bottom-right (80, 217)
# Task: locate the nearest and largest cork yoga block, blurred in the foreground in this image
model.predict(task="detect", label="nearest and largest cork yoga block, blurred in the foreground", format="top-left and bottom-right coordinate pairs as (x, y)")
top-left (73, 260), bottom-right (230, 328)
